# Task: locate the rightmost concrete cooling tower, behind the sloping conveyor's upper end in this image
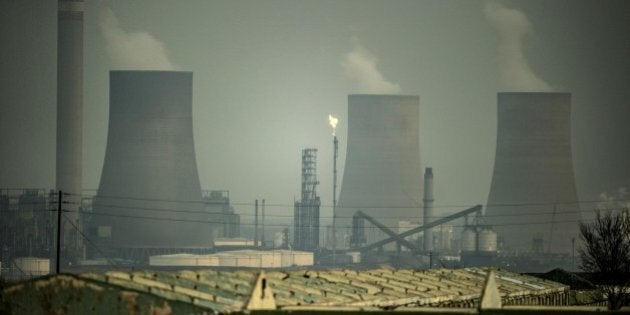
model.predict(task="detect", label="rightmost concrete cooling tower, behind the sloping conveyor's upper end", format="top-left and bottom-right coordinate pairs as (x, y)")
top-left (486, 93), bottom-right (581, 253)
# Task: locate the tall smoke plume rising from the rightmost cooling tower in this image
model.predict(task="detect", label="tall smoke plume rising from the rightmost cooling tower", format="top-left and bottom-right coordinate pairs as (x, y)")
top-left (484, 2), bottom-right (554, 92)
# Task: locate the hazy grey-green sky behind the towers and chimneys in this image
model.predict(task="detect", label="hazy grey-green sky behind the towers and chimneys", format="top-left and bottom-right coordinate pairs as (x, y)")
top-left (0, 0), bottom-right (630, 227)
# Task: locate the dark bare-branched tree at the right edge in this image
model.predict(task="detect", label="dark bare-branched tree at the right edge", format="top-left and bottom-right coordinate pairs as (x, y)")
top-left (579, 211), bottom-right (630, 310)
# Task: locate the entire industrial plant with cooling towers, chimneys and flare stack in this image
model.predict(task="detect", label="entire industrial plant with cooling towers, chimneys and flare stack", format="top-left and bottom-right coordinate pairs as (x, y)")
top-left (0, 0), bottom-right (604, 282)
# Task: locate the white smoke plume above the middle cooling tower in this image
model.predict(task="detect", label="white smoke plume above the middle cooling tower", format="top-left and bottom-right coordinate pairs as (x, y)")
top-left (341, 43), bottom-right (401, 94)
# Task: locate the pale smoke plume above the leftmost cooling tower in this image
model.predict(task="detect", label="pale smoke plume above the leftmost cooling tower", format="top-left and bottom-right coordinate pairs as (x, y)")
top-left (99, 8), bottom-right (176, 70)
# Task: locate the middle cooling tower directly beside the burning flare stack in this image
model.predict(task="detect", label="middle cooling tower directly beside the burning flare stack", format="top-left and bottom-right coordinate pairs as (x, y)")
top-left (335, 95), bottom-right (422, 248)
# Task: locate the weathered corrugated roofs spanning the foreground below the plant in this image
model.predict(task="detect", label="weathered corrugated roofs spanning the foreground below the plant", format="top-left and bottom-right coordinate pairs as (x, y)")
top-left (3, 268), bottom-right (569, 313)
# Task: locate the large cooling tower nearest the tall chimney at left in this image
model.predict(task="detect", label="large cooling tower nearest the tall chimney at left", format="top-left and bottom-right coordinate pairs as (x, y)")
top-left (94, 71), bottom-right (212, 248)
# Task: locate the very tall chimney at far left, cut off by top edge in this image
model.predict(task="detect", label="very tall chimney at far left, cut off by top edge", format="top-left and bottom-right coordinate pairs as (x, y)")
top-left (56, 0), bottom-right (84, 223)
